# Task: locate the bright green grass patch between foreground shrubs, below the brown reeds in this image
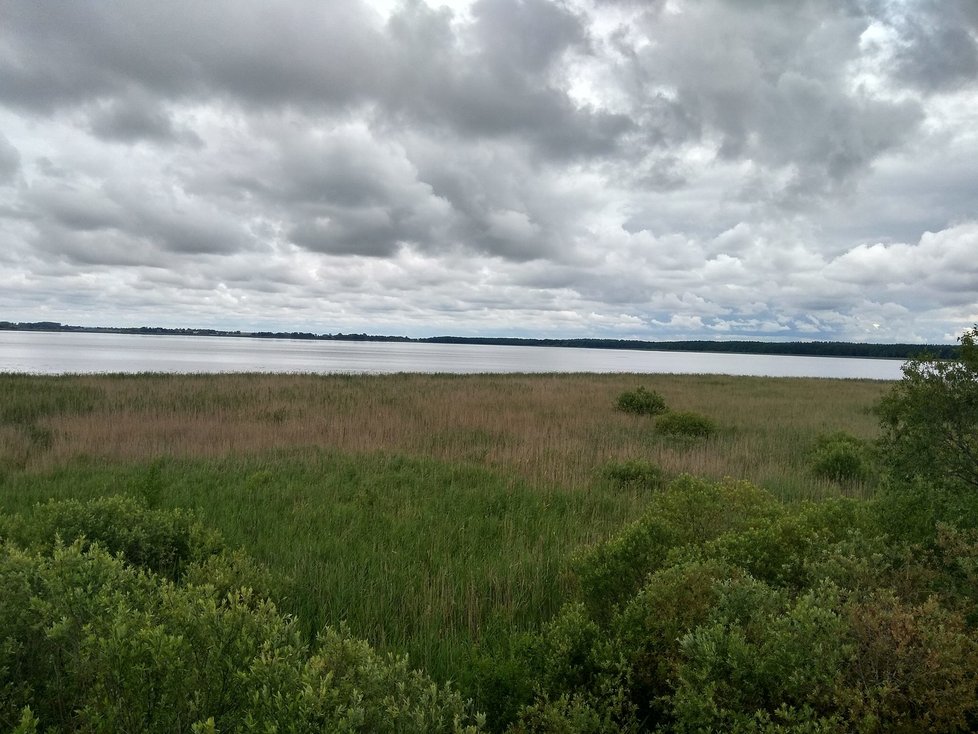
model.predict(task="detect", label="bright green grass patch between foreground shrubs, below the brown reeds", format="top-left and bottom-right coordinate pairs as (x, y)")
top-left (0, 451), bottom-right (643, 678)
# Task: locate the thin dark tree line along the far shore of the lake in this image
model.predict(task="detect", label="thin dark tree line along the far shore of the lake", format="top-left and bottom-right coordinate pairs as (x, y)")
top-left (0, 321), bottom-right (959, 359)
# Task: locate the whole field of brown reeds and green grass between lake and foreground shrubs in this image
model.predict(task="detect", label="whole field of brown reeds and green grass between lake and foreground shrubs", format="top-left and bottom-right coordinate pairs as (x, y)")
top-left (0, 375), bottom-right (888, 678)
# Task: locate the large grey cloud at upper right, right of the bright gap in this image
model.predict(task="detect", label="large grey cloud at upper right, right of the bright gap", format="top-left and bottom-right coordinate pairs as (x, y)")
top-left (616, 0), bottom-right (923, 202)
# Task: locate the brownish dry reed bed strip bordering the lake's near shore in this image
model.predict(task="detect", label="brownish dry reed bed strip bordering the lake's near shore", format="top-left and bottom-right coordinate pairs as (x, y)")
top-left (0, 374), bottom-right (887, 498)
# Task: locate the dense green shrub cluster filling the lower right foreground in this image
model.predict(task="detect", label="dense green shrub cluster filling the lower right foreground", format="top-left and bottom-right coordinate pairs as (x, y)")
top-left (478, 477), bottom-right (978, 732)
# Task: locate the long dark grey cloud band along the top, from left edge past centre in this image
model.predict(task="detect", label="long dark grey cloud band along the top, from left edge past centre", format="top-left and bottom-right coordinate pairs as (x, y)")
top-left (0, 0), bottom-right (629, 162)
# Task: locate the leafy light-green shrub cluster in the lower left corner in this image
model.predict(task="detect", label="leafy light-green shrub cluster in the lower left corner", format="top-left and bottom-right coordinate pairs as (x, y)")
top-left (0, 498), bottom-right (482, 733)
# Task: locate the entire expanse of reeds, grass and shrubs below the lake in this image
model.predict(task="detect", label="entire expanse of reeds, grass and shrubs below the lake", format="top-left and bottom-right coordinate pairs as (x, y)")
top-left (0, 332), bottom-right (978, 734)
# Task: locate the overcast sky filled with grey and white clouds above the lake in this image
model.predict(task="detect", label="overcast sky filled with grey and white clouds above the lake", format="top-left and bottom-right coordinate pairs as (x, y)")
top-left (0, 0), bottom-right (978, 343)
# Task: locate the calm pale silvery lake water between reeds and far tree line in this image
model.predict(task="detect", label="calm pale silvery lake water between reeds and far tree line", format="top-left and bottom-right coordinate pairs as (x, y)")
top-left (0, 331), bottom-right (902, 380)
